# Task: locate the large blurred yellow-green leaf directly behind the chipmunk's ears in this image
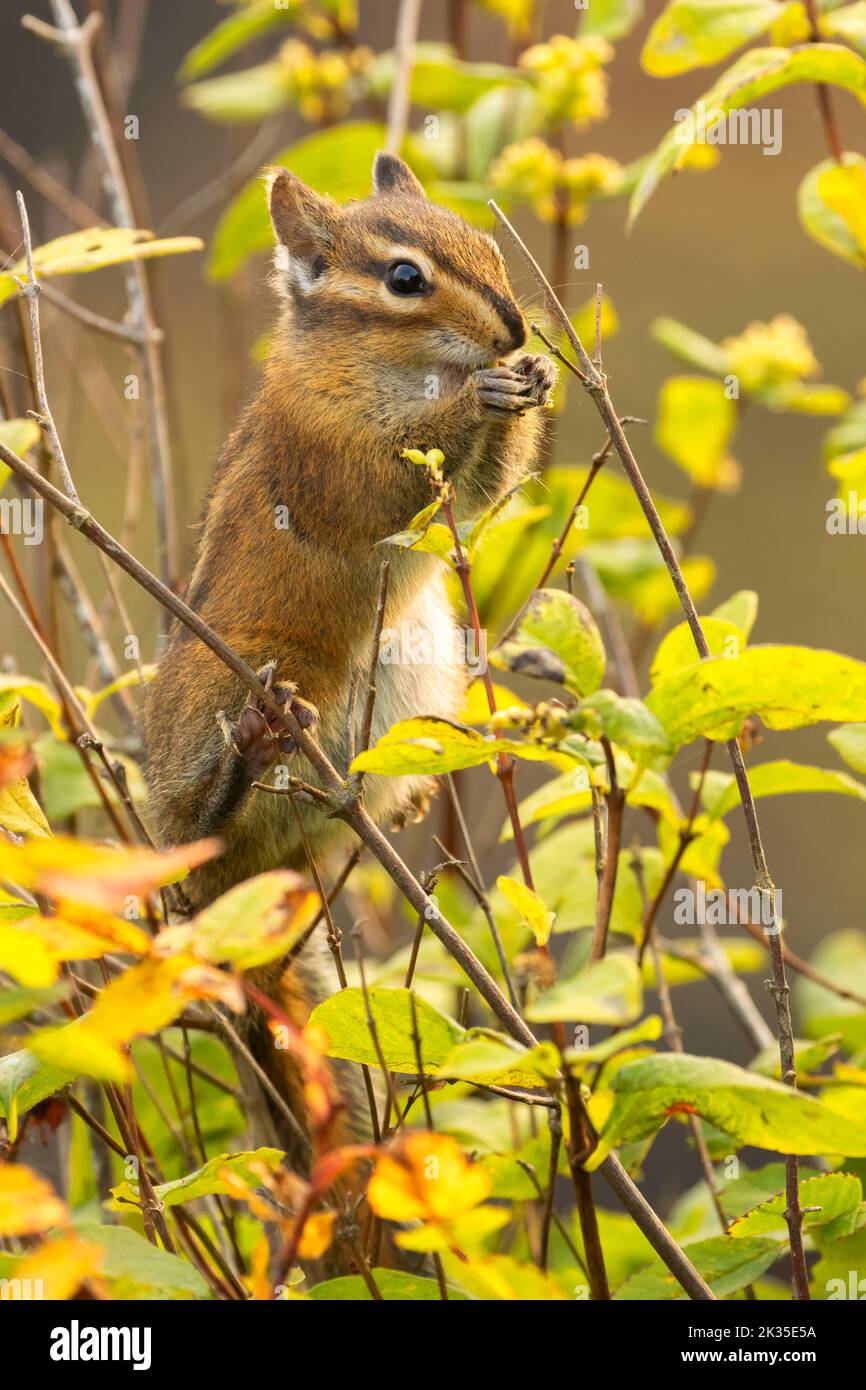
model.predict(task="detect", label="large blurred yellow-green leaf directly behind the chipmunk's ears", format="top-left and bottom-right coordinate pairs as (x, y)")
top-left (207, 121), bottom-right (385, 279)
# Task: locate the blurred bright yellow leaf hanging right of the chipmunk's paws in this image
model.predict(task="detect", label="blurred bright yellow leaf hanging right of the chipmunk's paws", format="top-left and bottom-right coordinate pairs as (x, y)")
top-left (656, 377), bottom-right (738, 491)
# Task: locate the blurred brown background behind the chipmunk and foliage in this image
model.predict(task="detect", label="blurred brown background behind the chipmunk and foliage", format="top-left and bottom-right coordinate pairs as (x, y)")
top-left (0, 0), bottom-right (866, 1212)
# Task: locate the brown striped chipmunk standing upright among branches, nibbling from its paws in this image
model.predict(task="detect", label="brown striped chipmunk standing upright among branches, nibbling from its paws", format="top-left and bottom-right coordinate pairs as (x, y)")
top-left (145, 154), bottom-right (556, 1170)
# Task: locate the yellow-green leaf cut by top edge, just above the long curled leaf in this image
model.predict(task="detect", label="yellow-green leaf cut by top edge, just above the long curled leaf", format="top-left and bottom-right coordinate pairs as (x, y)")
top-left (641, 0), bottom-right (785, 78)
